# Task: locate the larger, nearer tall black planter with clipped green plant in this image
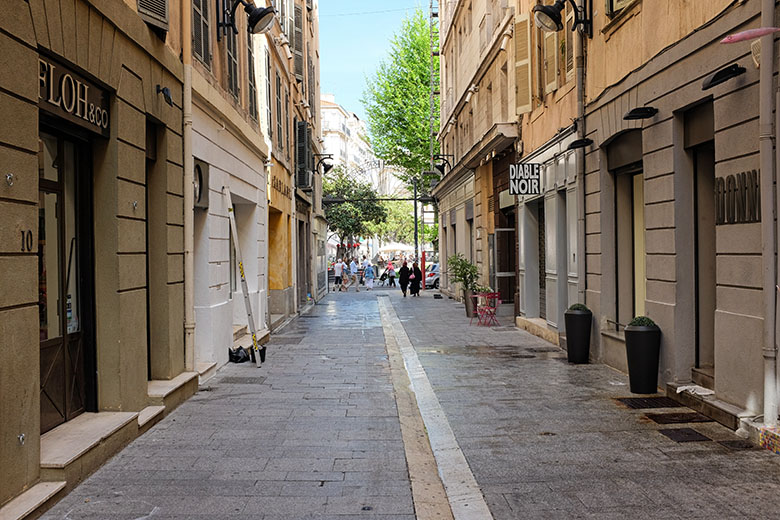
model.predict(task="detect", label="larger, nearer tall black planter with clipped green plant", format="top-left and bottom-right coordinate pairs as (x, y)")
top-left (625, 316), bottom-right (661, 394)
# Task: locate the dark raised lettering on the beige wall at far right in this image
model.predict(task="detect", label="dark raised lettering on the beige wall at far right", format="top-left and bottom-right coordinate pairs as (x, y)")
top-left (715, 170), bottom-right (761, 225)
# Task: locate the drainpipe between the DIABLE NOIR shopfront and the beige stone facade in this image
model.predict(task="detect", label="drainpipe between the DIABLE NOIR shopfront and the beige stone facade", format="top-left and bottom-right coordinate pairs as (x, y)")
top-left (574, 0), bottom-right (588, 303)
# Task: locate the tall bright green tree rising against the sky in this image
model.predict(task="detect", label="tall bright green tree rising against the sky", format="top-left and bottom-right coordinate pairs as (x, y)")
top-left (362, 9), bottom-right (439, 192)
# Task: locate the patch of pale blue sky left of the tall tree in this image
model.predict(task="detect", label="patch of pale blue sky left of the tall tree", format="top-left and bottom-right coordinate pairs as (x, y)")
top-left (319, 0), bottom-right (428, 119)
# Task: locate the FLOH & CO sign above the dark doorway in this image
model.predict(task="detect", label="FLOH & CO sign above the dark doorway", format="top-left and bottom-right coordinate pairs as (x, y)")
top-left (38, 56), bottom-right (110, 137)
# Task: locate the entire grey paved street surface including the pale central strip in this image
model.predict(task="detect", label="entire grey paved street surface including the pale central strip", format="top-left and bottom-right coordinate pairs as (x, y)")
top-left (43, 289), bottom-right (780, 520)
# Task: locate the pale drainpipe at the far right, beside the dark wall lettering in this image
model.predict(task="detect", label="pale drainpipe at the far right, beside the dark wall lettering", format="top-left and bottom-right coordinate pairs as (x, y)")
top-left (759, 0), bottom-right (777, 426)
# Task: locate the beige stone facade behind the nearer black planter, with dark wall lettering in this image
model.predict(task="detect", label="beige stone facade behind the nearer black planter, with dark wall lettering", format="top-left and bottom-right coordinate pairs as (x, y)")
top-left (585, 0), bottom-right (764, 420)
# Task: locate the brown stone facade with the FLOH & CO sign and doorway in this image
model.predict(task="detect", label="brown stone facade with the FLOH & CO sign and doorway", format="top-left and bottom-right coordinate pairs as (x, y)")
top-left (0, 0), bottom-right (197, 518)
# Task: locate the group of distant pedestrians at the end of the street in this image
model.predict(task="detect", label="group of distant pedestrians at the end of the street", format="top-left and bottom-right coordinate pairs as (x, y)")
top-left (333, 256), bottom-right (423, 298)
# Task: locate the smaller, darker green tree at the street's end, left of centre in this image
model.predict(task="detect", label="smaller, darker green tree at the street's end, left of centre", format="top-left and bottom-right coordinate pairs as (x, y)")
top-left (322, 166), bottom-right (387, 247)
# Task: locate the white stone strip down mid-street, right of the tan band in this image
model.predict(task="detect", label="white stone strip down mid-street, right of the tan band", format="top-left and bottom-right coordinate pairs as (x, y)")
top-left (377, 297), bottom-right (493, 520)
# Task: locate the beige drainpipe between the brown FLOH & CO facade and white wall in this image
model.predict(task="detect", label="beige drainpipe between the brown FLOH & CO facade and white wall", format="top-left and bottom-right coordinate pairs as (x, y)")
top-left (181, 2), bottom-right (195, 372)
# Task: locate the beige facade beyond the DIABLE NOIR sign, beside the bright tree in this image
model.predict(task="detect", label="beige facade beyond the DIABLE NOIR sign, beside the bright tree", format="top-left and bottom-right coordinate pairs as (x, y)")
top-left (433, 0), bottom-right (520, 304)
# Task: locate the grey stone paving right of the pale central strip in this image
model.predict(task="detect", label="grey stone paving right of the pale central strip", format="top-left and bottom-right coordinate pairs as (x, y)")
top-left (391, 294), bottom-right (780, 520)
